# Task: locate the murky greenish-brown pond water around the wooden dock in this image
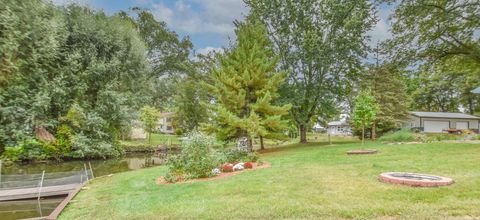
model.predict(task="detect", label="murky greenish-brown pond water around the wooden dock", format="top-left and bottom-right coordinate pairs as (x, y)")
top-left (0, 153), bottom-right (172, 220)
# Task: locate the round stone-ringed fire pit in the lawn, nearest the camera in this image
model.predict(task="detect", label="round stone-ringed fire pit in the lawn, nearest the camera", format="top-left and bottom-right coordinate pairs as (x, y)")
top-left (379, 172), bottom-right (454, 187)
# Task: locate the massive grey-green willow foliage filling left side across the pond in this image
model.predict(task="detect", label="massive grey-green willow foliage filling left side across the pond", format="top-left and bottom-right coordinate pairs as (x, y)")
top-left (0, 0), bottom-right (192, 158)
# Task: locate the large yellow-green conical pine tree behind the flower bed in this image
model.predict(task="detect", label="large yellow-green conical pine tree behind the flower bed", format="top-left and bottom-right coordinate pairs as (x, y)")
top-left (203, 17), bottom-right (290, 151)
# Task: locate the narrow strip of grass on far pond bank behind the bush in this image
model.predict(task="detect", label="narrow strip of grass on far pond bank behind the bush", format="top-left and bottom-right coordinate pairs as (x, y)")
top-left (120, 133), bottom-right (180, 151)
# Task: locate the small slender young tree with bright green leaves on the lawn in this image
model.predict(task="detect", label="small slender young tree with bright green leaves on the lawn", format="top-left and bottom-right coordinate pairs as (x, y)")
top-left (352, 91), bottom-right (378, 143)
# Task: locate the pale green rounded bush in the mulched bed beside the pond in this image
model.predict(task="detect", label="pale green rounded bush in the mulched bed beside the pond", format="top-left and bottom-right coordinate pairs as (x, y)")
top-left (165, 132), bottom-right (220, 182)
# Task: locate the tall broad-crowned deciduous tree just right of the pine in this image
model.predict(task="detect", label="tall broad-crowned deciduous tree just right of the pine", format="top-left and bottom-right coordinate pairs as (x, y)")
top-left (245, 0), bottom-right (375, 142)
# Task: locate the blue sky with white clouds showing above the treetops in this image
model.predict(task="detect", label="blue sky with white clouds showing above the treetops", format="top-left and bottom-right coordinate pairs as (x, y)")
top-left (52, 0), bottom-right (392, 54)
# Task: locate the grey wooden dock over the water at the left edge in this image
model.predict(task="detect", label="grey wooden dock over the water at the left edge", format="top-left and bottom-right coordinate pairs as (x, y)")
top-left (0, 183), bottom-right (82, 201)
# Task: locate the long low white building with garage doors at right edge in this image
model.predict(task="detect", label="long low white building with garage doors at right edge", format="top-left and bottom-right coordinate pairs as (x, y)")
top-left (404, 112), bottom-right (480, 133)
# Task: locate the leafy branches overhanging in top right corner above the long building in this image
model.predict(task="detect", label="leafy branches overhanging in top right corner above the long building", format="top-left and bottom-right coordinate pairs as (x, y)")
top-left (388, 0), bottom-right (480, 63)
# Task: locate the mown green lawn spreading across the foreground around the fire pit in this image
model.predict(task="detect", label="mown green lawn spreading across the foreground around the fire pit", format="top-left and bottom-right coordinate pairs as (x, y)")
top-left (61, 142), bottom-right (480, 219)
